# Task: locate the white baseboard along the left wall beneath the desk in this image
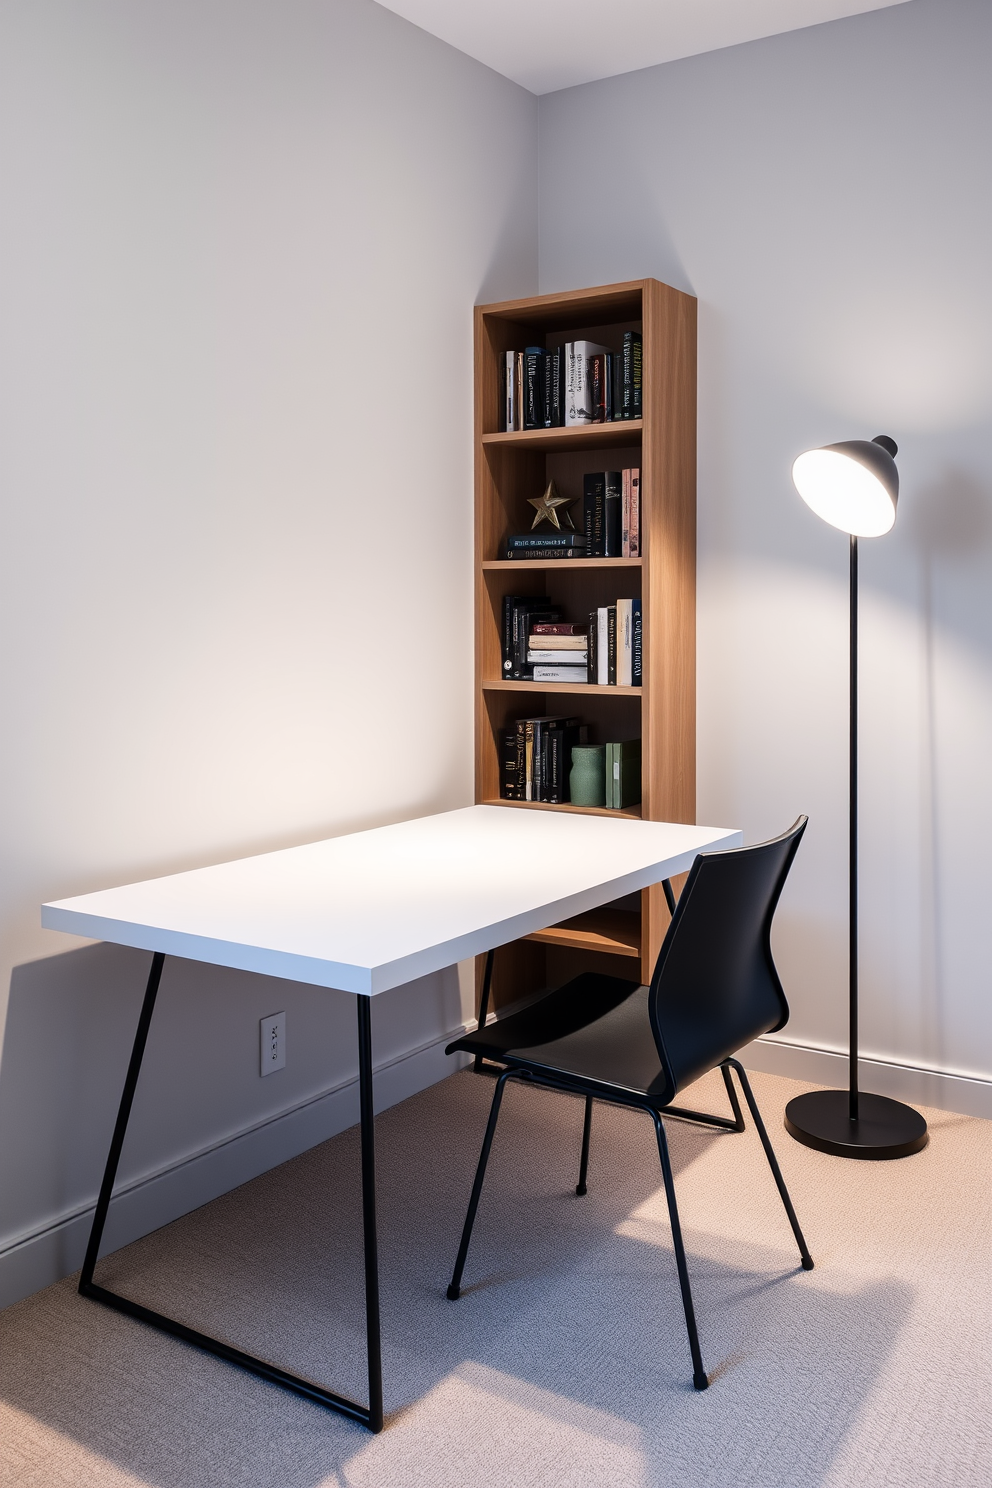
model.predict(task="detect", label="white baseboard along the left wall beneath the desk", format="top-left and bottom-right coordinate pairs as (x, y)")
top-left (0, 1025), bottom-right (468, 1308)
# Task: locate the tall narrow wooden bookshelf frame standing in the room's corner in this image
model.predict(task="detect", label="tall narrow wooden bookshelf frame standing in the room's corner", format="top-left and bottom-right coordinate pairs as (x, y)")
top-left (474, 280), bottom-right (696, 1006)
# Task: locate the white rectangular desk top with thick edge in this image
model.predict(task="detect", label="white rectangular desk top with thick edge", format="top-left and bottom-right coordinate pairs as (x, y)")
top-left (42, 806), bottom-right (742, 994)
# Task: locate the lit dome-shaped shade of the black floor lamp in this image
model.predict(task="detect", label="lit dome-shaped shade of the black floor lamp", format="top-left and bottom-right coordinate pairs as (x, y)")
top-left (793, 434), bottom-right (898, 537)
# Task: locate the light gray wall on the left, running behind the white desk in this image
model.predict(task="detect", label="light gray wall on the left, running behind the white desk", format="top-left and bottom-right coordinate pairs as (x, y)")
top-left (0, 0), bottom-right (537, 1296)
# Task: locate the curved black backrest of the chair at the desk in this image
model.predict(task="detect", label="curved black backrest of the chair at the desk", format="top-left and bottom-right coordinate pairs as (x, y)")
top-left (648, 817), bottom-right (808, 1100)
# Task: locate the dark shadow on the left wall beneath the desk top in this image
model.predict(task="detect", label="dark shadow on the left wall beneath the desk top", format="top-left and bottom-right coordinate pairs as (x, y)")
top-left (0, 945), bottom-right (461, 1274)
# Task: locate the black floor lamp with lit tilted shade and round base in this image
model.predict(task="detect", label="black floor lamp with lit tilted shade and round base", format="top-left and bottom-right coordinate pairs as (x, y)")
top-left (785, 434), bottom-right (927, 1159)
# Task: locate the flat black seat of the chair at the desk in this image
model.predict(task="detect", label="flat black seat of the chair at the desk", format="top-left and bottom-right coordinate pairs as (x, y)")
top-left (446, 972), bottom-right (671, 1100)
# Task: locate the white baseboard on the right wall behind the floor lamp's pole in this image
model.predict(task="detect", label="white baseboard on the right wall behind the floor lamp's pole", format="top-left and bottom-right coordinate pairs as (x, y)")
top-left (739, 1037), bottom-right (992, 1120)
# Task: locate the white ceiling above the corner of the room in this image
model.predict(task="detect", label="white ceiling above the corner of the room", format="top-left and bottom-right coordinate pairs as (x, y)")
top-left (379, 0), bottom-right (906, 94)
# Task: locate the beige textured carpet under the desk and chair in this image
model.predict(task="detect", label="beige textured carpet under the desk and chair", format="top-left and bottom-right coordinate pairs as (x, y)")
top-left (0, 1073), bottom-right (992, 1488)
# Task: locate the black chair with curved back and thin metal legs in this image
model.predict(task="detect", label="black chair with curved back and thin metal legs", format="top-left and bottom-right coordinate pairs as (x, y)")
top-left (446, 817), bottom-right (814, 1390)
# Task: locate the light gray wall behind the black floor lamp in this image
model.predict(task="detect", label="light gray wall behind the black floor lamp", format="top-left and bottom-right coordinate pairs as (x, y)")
top-left (540, 0), bottom-right (992, 1080)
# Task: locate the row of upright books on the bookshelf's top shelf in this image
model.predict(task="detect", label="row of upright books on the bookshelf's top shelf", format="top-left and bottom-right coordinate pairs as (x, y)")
top-left (503, 330), bottom-right (642, 432)
